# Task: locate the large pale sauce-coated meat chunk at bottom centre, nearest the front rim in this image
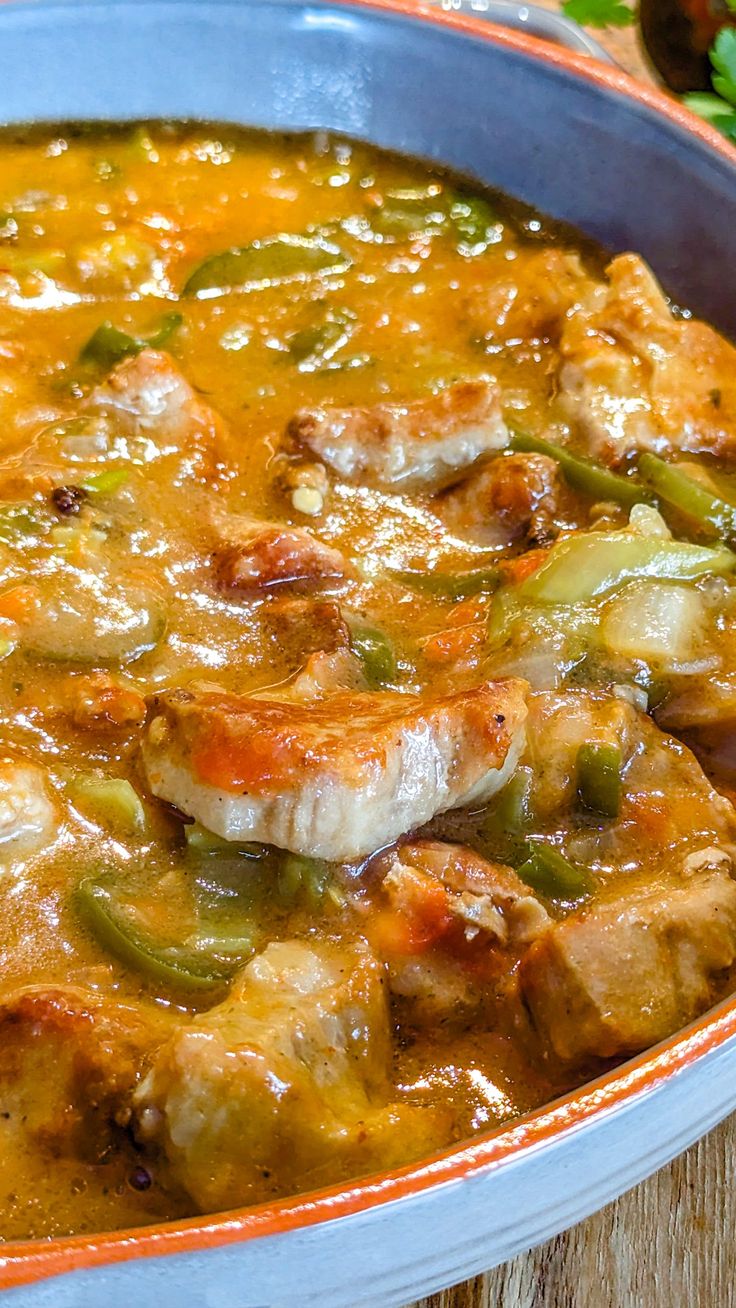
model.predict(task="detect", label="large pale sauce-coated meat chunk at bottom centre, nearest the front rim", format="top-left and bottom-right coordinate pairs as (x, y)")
top-left (136, 942), bottom-right (447, 1213)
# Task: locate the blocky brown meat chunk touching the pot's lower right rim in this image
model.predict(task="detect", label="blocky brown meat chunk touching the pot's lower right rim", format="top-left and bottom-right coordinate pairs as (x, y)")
top-left (522, 866), bottom-right (736, 1063)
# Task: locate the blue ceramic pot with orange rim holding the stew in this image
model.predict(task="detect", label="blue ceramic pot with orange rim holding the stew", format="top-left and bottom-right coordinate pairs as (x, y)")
top-left (0, 0), bottom-right (736, 1308)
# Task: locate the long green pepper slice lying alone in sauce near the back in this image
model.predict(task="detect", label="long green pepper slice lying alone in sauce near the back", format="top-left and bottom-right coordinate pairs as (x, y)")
top-left (182, 234), bottom-right (352, 298)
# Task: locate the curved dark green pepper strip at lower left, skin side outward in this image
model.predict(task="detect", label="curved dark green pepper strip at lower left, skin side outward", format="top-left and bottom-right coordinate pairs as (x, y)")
top-left (73, 878), bottom-right (254, 990)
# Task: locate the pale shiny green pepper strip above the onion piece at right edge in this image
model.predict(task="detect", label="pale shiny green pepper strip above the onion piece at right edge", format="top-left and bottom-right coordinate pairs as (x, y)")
top-left (519, 531), bottom-right (736, 604)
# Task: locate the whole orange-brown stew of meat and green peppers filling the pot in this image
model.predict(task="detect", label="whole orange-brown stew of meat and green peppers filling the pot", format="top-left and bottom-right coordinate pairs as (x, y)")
top-left (0, 123), bottom-right (736, 1239)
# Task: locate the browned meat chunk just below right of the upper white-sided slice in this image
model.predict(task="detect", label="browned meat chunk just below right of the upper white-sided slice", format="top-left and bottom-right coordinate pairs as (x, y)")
top-left (437, 454), bottom-right (561, 547)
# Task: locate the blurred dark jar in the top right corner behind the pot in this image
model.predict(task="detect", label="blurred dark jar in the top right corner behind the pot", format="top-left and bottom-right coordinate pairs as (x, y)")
top-left (639, 0), bottom-right (736, 92)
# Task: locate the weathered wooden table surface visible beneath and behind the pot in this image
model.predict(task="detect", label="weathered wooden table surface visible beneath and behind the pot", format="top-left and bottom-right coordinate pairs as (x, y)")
top-left (407, 10), bottom-right (736, 1308)
